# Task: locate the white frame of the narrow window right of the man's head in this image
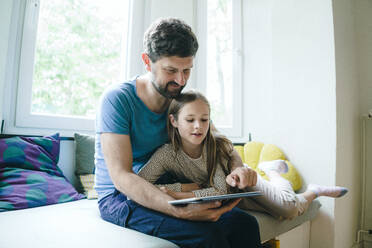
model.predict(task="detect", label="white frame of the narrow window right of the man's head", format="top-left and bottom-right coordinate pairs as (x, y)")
top-left (195, 0), bottom-right (243, 138)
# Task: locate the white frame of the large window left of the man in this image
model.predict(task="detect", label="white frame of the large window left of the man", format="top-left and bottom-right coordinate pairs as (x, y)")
top-left (4, 0), bottom-right (134, 136)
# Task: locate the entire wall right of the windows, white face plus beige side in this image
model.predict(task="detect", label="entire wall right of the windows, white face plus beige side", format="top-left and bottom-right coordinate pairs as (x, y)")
top-left (243, 0), bottom-right (366, 248)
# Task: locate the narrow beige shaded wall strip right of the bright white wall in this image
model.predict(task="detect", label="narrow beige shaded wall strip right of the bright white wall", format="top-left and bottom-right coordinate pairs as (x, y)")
top-left (333, 0), bottom-right (361, 247)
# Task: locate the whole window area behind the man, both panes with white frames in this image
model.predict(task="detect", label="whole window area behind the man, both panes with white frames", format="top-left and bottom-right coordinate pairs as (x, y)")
top-left (5, 0), bottom-right (243, 138)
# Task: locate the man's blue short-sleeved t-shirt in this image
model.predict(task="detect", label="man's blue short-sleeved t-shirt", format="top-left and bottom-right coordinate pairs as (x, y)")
top-left (95, 78), bottom-right (168, 199)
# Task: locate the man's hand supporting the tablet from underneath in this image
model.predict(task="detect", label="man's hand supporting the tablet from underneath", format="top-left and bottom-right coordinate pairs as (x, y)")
top-left (175, 198), bottom-right (241, 222)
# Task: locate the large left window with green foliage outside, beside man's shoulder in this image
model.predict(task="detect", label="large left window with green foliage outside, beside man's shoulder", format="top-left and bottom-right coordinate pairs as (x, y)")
top-left (16, 0), bottom-right (129, 131)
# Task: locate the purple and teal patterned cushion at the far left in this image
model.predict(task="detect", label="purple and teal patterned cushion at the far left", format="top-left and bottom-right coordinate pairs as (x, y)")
top-left (0, 134), bottom-right (84, 211)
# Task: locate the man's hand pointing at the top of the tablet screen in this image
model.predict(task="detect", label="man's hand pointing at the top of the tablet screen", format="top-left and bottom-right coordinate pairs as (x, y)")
top-left (226, 166), bottom-right (257, 189)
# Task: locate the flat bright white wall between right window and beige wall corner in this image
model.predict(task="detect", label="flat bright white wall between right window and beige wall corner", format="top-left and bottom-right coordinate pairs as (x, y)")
top-left (243, 0), bottom-right (342, 248)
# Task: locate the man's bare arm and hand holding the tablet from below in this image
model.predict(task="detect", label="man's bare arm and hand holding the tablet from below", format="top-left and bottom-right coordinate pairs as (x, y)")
top-left (101, 133), bottom-right (239, 221)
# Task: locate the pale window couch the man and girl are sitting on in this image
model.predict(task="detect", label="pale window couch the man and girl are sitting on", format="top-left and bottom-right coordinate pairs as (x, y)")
top-left (0, 135), bottom-right (321, 248)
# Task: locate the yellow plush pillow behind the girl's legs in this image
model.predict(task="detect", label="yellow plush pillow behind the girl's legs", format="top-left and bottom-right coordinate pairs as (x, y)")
top-left (234, 141), bottom-right (302, 191)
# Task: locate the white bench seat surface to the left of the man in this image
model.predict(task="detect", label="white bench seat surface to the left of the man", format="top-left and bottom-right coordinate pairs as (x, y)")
top-left (0, 199), bottom-right (177, 248)
